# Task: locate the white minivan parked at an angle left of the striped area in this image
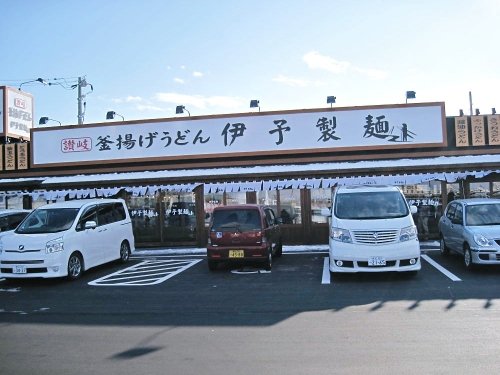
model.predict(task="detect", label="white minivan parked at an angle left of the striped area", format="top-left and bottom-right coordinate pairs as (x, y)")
top-left (0, 199), bottom-right (135, 279)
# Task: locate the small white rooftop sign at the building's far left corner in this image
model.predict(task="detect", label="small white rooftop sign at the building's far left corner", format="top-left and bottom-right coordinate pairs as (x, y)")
top-left (5, 87), bottom-right (33, 140)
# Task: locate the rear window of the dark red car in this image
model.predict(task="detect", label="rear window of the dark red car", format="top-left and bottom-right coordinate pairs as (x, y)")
top-left (212, 209), bottom-right (261, 231)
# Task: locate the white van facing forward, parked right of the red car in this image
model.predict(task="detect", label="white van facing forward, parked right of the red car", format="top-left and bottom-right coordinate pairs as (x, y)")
top-left (323, 185), bottom-right (421, 272)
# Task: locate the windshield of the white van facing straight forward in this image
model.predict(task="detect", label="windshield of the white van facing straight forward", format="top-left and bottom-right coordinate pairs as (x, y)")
top-left (335, 191), bottom-right (408, 220)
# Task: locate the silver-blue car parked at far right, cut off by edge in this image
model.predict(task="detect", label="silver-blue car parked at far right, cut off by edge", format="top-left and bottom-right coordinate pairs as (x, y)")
top-left (439, 198), bottom-right (500, 269)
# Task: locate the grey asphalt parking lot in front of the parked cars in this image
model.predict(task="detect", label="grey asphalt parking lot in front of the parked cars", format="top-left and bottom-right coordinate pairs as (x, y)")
top-left (0, 250), bottom-right (500, 375)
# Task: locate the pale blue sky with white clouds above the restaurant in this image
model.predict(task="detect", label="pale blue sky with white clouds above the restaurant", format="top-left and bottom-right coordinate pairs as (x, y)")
top-left (0, 0), bottom-right (500, 127)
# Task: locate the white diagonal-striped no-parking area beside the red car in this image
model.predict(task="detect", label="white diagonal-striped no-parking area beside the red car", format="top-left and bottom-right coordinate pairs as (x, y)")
top-left (88, 259), bottom-right (202, 286)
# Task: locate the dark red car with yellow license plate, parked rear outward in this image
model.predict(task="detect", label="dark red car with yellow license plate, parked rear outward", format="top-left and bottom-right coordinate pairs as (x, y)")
top-left (207, 204), bottom-right (283, 271)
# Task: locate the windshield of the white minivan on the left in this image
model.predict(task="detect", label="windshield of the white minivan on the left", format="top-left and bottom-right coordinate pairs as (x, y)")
top-left (16, 208), bottom-right (79, 234)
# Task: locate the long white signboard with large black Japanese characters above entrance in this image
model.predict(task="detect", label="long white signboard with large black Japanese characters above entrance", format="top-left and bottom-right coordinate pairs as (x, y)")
top-left (32, 103), bottom-right (445, 166)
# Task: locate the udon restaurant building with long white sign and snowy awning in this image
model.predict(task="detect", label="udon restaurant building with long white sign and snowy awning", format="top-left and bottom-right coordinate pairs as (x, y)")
top-left (0, 87), bottom-right (500, 247)
